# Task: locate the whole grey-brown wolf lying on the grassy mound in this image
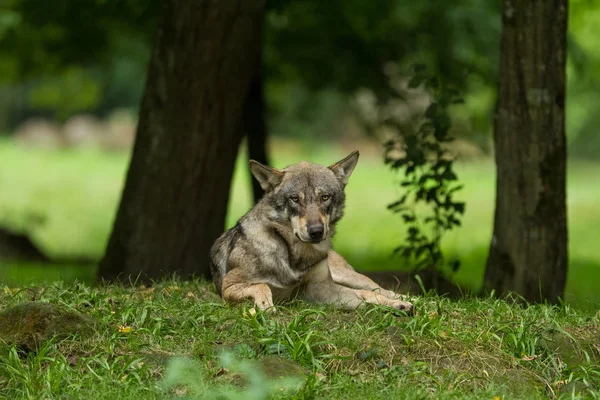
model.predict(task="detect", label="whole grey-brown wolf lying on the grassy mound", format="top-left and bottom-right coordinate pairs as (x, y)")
top-left (211, 151), bottom-right (413, 312)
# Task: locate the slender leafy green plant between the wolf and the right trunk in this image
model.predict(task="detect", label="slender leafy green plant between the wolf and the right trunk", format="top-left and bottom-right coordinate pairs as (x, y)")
top-left (385, 65), bottom-right (465, 278)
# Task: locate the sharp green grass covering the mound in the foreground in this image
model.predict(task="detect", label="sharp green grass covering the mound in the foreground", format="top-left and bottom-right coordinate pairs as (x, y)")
top-left (0, 281), bottom-right (600, 400)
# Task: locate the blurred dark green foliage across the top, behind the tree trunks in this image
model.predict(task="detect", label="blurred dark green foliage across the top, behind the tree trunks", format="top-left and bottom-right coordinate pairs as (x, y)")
top-left (0, 0), bottom-right (600, 155)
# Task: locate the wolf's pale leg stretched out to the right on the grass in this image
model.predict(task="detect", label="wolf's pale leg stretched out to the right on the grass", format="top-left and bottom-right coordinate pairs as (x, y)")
top-left (303, 260), bottom-right (413, 312)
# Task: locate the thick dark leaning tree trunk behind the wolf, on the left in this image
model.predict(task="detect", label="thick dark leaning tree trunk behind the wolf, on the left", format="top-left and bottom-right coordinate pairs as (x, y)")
top-left (98, 0), bottom-right (264, 280)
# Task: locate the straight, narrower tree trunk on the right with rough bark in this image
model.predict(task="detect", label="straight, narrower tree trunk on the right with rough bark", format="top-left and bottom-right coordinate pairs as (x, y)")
top-left (485, 0), bottom-right (568, 302)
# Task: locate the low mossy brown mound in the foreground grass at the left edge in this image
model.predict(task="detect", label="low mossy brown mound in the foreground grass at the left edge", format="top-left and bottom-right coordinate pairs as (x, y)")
top-left (0, 301), bottom-right (98, 351)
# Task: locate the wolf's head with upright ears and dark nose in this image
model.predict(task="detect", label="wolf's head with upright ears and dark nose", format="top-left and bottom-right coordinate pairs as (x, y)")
top-left (250, 151), bottom-right (358, 243)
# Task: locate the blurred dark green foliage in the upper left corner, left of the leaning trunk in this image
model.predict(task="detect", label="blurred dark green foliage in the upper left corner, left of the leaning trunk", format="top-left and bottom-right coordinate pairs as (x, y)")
top-left (0, 0), bottom-right (160, 125)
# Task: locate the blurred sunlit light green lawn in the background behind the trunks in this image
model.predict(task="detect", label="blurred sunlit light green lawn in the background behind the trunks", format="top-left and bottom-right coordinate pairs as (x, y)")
top-left (0, 140), bottom-right (600, 305)
